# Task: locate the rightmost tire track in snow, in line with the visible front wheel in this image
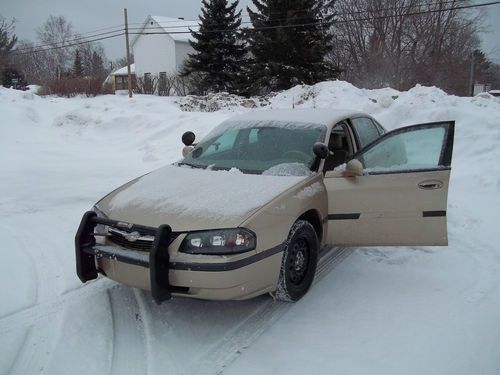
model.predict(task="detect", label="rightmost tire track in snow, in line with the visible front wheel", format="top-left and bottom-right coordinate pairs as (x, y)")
top-left (182, 248), bottom-right (354, 375)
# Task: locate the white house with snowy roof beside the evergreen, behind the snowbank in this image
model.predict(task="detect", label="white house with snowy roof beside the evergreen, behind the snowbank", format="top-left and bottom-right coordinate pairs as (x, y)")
top-left (130, 16), bottom-right (199, 79)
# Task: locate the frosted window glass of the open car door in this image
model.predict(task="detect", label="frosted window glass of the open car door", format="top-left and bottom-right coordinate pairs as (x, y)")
top-left (358, 127), bottom-right (446, 174)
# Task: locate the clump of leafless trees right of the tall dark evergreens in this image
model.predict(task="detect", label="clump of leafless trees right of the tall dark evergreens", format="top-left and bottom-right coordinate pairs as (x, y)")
top-left (330, 0), bottom-right (481, 93)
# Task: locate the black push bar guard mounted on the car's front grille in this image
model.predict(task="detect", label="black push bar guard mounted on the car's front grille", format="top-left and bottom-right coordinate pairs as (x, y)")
top-left (75, 211), bottom-right (172, 304)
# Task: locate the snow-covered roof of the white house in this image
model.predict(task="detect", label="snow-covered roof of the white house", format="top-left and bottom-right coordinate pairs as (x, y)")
top-left (132, 16), bottom-right (199, 45)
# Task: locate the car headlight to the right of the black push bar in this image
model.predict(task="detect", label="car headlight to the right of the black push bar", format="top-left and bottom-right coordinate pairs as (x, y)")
top-left (179, 228), bottom-right (257, 255)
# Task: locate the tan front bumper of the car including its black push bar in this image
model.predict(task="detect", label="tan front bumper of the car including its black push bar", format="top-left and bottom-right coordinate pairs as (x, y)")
top-left (75, 211), bottom-right (284, 303)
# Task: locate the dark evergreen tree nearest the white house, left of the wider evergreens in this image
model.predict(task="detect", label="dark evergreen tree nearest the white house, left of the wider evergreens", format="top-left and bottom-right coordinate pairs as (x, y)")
top-left (181, 0), bottom-right (246, 93)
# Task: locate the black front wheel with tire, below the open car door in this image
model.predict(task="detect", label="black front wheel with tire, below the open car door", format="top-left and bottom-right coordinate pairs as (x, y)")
top-left (276, 220), bottom-right (319, 302)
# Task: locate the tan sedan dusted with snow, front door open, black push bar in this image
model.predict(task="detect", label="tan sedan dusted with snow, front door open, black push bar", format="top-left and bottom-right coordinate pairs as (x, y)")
top-left (75, 109), bottom-right (454, 303)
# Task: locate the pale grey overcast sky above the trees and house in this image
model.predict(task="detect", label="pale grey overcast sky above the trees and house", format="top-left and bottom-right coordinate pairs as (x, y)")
top-left (0, 0), bottom-right (500, 63)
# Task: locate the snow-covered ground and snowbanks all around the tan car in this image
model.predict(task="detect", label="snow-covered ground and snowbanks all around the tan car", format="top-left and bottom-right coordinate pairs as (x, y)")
top-left (0, 82), bottom-right (500, 375)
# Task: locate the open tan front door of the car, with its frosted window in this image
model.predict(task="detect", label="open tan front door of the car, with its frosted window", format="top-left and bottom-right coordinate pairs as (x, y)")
top-left (324, 121), bottom-right (455, 246)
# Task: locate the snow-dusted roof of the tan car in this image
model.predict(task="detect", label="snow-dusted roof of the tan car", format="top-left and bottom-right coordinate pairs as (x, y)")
top-left (227, 108), bottom-right (371, 126)
